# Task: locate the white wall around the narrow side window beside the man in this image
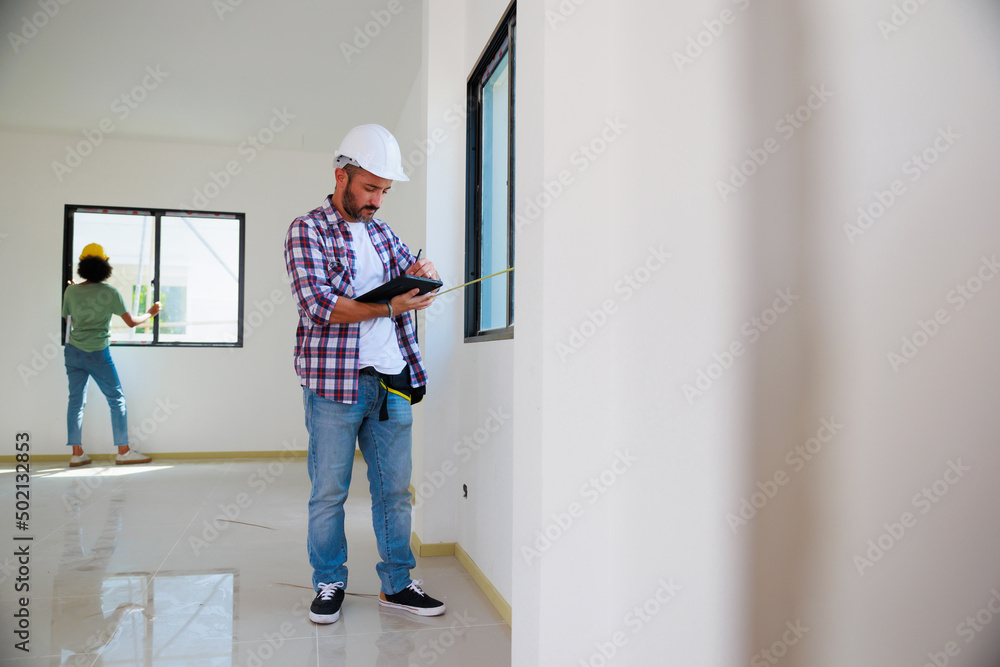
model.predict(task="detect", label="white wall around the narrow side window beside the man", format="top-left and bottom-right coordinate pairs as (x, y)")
top-left (414, 0), bottom-right (514, 601)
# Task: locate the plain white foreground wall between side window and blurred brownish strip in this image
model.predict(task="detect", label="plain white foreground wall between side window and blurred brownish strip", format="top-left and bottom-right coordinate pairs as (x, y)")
top-left (512, 2), bottom-right (749, 665)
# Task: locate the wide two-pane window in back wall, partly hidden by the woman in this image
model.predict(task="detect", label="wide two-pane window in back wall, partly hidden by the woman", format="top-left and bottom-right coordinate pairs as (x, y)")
top-left (62, 205), bottom-right (245, 347)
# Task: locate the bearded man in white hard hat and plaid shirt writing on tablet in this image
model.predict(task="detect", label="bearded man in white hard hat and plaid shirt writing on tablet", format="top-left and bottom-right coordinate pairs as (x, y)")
top-left (285, 125), bottom-right (445, 623)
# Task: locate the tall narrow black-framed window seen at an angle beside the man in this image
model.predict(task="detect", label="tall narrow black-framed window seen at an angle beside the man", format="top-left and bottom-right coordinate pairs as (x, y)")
top-left (465, 5), bottom-right (515, 340)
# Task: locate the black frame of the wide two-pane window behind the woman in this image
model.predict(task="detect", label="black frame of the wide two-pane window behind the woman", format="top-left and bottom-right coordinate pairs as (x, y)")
top-left (59, 204), bottom-right (247, 348)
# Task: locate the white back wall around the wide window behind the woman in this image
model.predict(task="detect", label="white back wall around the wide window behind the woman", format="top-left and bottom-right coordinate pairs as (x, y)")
top-left (0, 128), bottom-right (422, 455)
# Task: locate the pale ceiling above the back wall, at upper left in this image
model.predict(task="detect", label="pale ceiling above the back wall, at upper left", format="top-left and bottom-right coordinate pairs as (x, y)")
top-left (0, 0), bottom-right (423, 152)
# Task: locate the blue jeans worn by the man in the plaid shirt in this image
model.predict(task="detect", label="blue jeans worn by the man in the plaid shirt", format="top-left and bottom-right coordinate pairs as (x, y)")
top-left (302, 375), bottom-right (416, 595)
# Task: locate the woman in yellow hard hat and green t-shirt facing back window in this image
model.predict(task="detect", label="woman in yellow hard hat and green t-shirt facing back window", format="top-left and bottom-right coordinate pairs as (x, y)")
top-left (62, 243), bottom-right (162, 468)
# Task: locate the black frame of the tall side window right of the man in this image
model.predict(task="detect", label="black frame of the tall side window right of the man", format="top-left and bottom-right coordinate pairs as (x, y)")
top-left (465, 2), bottom-right (517, 343)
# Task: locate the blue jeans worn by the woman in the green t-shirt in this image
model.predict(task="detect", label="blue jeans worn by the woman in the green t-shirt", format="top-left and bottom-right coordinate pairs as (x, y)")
top-left (63, 343), bottom-right (128, 447)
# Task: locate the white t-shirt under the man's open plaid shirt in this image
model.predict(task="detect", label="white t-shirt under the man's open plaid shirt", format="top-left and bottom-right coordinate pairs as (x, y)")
top-left (347, 222), bottom-right (406, 375)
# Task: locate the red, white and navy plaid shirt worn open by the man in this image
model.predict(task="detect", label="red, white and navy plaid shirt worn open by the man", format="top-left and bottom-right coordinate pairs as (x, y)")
top-left (285, 196), bottom-right (427, 403)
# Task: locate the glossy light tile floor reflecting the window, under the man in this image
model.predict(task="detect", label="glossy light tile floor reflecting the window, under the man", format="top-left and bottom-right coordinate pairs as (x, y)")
top-left (0, 459), bottom-right (510, 667)
